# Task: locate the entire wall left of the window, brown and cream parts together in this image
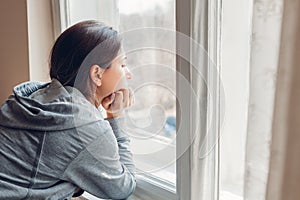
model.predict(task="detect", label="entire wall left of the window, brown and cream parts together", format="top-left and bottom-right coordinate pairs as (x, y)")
top-left (0, 0), bottom-right (54, 103)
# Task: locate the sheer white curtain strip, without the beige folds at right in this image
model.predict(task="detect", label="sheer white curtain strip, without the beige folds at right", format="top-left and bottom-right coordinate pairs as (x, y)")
top-left (244, 0), bottom-right (283, 200)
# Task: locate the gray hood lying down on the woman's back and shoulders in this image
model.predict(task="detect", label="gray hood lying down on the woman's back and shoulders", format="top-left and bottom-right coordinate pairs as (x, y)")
top-left (0, 79), bottom-right (103, 131)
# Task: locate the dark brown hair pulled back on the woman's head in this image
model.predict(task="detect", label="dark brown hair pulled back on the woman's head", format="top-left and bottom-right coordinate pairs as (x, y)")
top-left (50, 20), bottom-right (121, 89)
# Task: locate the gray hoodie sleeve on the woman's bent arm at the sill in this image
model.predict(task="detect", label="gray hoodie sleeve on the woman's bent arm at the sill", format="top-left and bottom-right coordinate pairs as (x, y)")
top-left (63, 119), bottom-right (136, 199)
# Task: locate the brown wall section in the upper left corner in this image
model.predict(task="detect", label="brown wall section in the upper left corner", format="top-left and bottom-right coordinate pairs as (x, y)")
top-left (0, 0), bottom-right (29, 103)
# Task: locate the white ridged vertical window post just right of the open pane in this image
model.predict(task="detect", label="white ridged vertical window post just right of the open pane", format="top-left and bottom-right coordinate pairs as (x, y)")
top-left (190, 0), bottom-right (222, 200)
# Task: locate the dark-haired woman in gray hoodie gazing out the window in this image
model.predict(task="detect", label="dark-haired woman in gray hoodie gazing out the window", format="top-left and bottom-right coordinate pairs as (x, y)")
top-left (0, 21), bottom-right (136, 200)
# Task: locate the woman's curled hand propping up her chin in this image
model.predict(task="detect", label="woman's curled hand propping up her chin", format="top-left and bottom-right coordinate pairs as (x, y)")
top-left (101, 89), bottom-right (134, 118)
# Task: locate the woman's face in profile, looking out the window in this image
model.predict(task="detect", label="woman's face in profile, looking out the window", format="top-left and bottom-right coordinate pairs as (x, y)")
top-left (96, 50), bottom-right (132, 102)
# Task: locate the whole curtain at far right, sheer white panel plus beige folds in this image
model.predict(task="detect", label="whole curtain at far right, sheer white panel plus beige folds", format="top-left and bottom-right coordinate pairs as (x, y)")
top-left (244, 0), bottom-right (300, 200)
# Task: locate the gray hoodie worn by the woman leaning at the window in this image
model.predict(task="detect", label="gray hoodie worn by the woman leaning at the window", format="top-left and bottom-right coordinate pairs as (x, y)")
top-left (0, 79), bottom-right (136, 200)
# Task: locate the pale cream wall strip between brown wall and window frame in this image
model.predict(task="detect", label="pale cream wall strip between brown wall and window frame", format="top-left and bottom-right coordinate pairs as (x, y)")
top-left (27, 0), bottom-right (54, 82)
